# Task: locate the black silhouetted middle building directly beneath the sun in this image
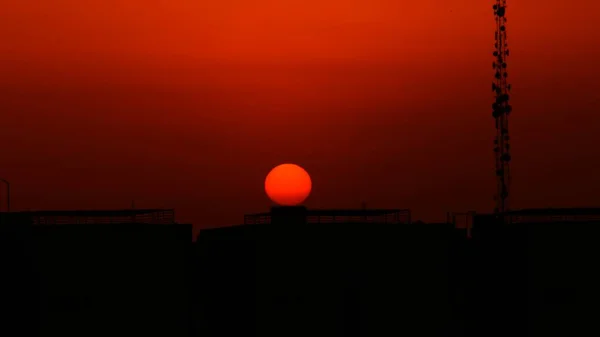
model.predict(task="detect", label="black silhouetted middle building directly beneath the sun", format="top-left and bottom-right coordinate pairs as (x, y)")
top-left (194, 208), bottom-right (466, 336)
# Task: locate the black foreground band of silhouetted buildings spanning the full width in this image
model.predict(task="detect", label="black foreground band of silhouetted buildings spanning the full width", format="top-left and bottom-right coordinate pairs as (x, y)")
top-left (0, 209), bottom-right (600, 336)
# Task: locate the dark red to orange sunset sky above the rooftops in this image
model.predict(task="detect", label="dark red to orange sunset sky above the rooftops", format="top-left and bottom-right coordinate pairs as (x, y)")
top-left (0, 0), bottom-right (600, 235)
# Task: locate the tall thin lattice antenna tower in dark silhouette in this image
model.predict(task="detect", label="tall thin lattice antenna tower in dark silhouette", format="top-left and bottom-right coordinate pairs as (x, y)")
top-left (492, 0), bottom-right (512, 214)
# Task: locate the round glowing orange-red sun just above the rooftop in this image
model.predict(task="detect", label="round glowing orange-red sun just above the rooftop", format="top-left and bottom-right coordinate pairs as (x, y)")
top-left (265, 164), bottom-right (312, 206)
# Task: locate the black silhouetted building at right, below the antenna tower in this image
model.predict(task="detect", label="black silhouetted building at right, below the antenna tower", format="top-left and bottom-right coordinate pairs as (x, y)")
top-left (469, 208), bottom-right (600, 336)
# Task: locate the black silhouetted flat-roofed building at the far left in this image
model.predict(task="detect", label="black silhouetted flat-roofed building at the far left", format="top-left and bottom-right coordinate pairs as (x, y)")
top-left (0, 210), bottom-right (191, 336)
